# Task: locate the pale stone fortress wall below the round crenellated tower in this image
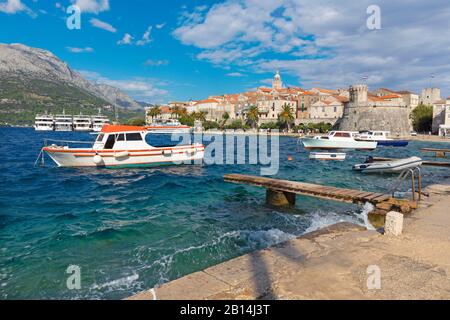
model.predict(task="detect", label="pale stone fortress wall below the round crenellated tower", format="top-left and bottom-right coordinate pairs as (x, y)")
top-left (336, 106), bottom-right (411, 137)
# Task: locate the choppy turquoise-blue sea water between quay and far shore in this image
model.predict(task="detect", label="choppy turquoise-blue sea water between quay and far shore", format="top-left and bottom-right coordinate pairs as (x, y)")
top-left (0, 128), bottom-right (450, 299)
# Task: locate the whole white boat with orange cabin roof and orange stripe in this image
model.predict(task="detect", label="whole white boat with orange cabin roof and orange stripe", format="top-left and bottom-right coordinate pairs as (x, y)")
top-left (42, 125), bottom-right (205, 168)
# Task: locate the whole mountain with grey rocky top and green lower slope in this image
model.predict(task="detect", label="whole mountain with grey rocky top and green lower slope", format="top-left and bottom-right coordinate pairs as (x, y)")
top-left (0, 44), bottom-right (144, 124)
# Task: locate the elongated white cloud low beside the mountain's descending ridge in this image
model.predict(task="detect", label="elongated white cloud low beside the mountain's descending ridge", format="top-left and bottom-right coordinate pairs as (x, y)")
top-left (78, 70), bottom-right (169, 102)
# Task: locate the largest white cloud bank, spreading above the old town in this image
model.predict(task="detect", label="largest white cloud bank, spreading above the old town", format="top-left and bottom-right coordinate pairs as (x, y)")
top-left (173, 0), bottom-right (450, 95)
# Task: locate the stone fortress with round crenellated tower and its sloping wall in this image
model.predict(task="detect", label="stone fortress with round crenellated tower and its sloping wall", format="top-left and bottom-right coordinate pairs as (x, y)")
top-left (335, 84), bottom-right (411, 137)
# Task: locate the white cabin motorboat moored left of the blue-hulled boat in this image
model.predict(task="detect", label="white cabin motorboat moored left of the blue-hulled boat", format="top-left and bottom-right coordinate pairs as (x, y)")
top-left (301, 131), bottom-right (378, 150)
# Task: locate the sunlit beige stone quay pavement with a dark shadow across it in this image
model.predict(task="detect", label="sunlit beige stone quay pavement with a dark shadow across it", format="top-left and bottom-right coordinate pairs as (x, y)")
top-left (130, 185), bottom-right (450, 300)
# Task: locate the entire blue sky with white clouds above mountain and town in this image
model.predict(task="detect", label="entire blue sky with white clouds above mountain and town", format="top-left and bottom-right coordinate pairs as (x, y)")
top-left (0, 0), bottom-right (450, 102)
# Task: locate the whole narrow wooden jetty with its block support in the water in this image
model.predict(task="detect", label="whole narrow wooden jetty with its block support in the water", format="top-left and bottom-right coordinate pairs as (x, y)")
top-left (224, 174), bottom-right (418, 213)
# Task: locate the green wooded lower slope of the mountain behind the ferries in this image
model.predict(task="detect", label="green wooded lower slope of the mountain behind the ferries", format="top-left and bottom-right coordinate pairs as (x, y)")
top-left (0, 76), bottom-right (144, 125)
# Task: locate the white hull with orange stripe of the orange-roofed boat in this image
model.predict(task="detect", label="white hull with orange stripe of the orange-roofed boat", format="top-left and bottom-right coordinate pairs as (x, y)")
top-left (43, 145), bottom-right (204, 168)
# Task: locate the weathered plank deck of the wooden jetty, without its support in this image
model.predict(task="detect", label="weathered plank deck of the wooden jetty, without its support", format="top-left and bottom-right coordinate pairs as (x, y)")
top-left (224, 174), bottom-right (391, 204)
